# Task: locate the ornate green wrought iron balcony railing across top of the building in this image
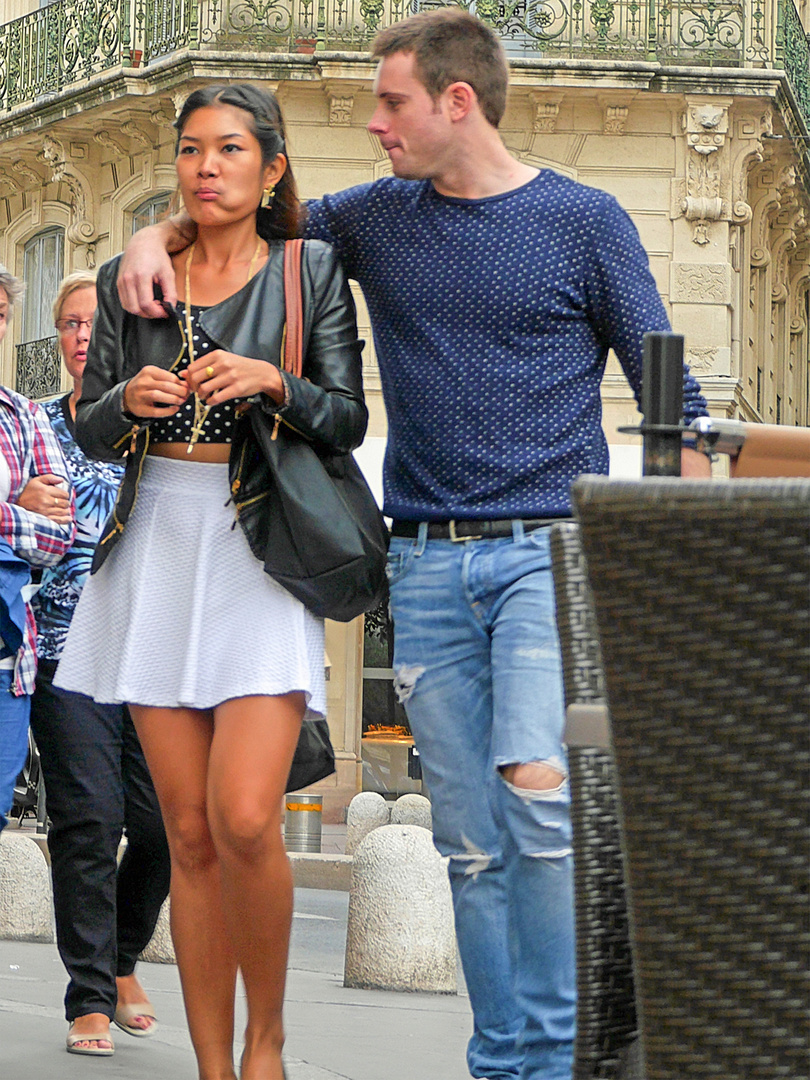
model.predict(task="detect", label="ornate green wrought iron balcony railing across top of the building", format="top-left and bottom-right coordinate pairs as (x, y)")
top-left (0, 0), bottom-right (810, 123)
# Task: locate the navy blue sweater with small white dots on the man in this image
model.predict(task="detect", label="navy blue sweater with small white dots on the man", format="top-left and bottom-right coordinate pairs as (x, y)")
top-left (307, 170), bottom-right (706, 521)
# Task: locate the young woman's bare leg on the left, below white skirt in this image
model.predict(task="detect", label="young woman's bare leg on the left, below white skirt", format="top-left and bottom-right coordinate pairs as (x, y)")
top-left (131, 705), bottom-right (237, 1080)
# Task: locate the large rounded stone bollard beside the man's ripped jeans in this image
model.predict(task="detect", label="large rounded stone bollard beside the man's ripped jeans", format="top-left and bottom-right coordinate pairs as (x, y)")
top-left (343, 825), bottom-right (457, 994)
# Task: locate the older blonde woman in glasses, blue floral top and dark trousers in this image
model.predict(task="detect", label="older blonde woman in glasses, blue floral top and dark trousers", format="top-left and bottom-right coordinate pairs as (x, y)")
top-left (31, 271), bottom-right (170, 1056)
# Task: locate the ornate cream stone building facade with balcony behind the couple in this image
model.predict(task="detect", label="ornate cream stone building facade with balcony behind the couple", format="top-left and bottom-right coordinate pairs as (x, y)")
top-left (0, 0), bottom-right (810, 802)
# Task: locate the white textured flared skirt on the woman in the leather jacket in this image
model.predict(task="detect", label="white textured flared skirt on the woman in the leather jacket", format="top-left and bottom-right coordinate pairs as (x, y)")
top-left (54, 456), bottom-right (326, 718)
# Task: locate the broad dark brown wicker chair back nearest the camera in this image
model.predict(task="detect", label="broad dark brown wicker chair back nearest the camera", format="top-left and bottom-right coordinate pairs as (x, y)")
top-left (573, 477), bottom-right (810, 1080)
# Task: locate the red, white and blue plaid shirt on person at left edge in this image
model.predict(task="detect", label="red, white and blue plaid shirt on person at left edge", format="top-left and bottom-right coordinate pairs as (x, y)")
top-left (0, 387), bottom-right (76, 697)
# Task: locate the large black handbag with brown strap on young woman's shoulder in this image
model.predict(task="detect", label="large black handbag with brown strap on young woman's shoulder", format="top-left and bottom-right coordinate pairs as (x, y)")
top-left (234, 241), bottom-right (388, 622)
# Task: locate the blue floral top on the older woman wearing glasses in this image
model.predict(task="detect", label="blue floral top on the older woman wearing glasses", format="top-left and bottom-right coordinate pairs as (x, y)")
top-left (33, 394), bottom-right (124, 660)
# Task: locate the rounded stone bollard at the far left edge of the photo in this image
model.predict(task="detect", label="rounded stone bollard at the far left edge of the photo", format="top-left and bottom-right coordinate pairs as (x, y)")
top-left (0, 828), bottom-right (54, 943)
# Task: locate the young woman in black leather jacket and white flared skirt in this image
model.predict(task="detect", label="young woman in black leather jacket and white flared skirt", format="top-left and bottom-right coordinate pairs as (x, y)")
top-left (56, 85), bottom-right (367, 1080)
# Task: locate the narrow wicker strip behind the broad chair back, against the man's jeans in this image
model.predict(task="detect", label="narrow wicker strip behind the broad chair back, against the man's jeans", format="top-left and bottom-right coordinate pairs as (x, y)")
top-left (551, 523), bottom-right (636, 1080)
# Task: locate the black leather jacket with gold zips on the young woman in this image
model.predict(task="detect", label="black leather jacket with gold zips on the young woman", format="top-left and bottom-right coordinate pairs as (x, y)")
top-left (76, 240), bottom-right (368, 571)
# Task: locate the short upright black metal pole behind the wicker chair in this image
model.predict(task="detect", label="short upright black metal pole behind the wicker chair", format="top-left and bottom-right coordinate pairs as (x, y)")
top-left (642, 332), bottom-right (684, 476)
